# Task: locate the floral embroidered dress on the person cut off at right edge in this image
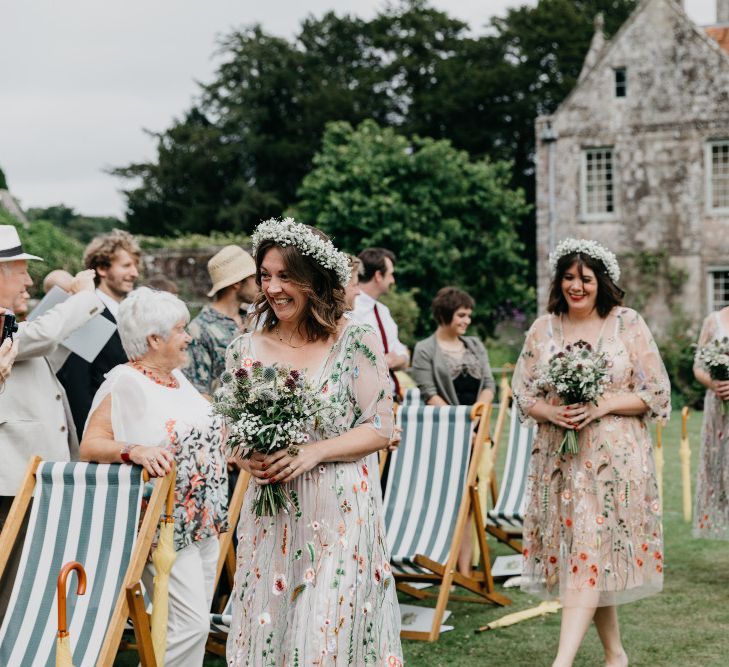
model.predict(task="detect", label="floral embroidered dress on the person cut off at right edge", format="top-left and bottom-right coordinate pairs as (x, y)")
top-left (693, 312), bottom-right (729, 540)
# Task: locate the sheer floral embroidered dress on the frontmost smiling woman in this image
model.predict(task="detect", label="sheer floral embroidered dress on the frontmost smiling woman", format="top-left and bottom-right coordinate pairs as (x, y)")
top-left (227, 322), bottom-right (402, 667)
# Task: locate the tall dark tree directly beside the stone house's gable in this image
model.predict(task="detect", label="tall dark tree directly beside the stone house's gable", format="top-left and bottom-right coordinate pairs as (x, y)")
top-left (382, 0), bottom-right (637, 264)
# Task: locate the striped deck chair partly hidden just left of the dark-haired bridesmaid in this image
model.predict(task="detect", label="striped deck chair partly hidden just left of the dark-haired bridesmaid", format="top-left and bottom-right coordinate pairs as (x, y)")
top-left (486, 381), bottom-right (537, 553)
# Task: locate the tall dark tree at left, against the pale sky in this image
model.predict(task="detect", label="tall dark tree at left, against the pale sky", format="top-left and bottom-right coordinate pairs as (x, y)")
top-left (113, 13), bottom-right (388, 234)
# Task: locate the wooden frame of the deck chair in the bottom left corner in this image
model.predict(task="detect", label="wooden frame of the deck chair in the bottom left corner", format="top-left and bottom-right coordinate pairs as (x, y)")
top-left (0, 456), bottom-right (174, 667)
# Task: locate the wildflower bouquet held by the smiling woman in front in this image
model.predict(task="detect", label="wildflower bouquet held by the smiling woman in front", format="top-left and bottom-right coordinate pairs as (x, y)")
top-left (213, 358), bottom-right (330, 516)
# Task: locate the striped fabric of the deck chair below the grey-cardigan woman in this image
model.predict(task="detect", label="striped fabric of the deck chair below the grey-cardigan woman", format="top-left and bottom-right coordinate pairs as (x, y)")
top-left (384, 404), bottom-right (473, 573)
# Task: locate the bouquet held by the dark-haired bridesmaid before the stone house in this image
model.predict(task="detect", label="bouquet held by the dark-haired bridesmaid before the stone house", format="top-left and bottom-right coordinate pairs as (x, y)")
top-left (537, 340), bottom-right (610, 454)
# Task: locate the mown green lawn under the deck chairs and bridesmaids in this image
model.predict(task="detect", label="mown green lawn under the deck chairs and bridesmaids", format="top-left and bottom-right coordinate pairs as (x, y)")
top-left (117, 413), bottom-right (729, 667)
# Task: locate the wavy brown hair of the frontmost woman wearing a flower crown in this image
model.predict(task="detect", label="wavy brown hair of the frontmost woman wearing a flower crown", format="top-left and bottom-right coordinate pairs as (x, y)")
top-left (255, 230), bottom-right (347, 341)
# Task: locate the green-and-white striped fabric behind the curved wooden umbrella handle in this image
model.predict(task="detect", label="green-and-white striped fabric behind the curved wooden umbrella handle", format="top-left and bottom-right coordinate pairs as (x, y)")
top-left (0, 462), bottom-right (144, 667)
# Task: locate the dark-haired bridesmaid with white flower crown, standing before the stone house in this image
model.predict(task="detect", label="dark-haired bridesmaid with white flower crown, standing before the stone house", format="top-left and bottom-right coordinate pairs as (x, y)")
top-left (512, 239), bottom-right (671, 667)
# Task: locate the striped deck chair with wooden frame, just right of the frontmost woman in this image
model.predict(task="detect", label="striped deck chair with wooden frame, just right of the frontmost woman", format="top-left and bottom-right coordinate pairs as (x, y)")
top-left (384, 403), bottom-right (511, 641)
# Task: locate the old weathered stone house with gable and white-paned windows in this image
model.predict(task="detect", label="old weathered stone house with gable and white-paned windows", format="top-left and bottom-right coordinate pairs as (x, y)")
top-left (536, 0), bottom-right (729, 332)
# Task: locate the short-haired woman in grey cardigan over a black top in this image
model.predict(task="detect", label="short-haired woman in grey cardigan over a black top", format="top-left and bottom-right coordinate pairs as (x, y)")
top-left (412, 287), bottom-right (495, 405)
